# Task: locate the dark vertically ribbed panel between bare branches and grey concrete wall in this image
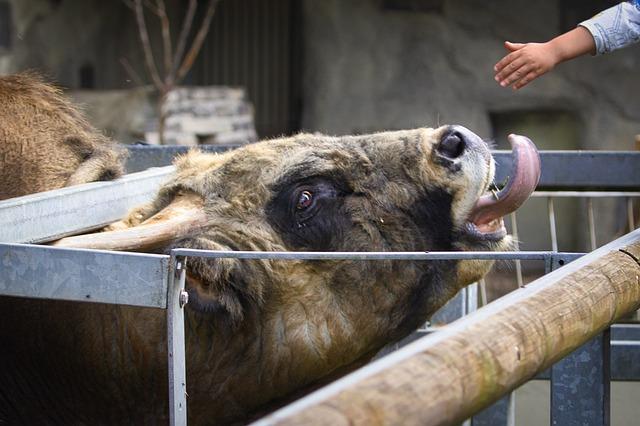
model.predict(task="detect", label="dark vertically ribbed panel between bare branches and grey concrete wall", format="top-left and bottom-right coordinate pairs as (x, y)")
top-left (188, 0), bottom-right (302, 138)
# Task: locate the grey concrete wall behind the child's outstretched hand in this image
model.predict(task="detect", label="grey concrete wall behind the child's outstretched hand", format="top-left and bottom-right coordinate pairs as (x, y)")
top-left (303, 0), bottom-right (640, 149)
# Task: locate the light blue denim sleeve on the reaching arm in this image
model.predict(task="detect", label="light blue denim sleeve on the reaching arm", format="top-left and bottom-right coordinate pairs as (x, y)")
top-left (579, 0), bottom-right (640, 55)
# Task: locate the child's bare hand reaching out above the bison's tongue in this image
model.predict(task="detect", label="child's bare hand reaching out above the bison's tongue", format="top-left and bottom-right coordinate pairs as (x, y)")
top-left (493, 41), bottom-right (560, 90)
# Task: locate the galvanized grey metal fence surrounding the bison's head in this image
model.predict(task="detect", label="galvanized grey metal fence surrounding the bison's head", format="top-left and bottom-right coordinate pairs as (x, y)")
top-left (0, 147), bottom-right (640, 425)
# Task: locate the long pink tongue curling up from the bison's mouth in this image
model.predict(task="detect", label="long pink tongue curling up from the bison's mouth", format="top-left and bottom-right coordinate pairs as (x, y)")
top-left (469, 134), bottom-right (540, 225)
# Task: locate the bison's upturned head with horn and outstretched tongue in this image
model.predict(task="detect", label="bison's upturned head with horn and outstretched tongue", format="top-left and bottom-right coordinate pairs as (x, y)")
top-left (52, 126), bottom-right (538, 422)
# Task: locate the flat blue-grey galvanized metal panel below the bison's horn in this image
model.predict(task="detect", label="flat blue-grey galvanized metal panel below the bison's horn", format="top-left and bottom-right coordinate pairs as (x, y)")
top-left (0, 244), bottom-right (169, 308)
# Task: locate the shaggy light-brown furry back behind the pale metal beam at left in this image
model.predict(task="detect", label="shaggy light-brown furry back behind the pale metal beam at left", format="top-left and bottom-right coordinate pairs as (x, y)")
top-left (0, 73), bottom-right (124, 200)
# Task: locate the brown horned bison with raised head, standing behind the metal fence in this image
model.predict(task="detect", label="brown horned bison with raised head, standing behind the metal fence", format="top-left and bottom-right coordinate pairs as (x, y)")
top-left (0, 120), bottom-right (536, 424)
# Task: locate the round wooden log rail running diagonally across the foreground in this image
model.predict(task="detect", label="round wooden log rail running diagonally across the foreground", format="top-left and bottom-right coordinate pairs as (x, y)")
top-left (256, 230), bottom-right (640, 425)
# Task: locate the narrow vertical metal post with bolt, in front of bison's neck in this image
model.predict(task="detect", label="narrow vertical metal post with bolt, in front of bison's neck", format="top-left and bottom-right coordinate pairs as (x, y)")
top-left (167, 256), bottom-right (187, 426)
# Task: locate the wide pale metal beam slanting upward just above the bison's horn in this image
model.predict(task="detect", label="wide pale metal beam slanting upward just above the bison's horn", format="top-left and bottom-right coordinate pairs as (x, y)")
top-left (0, 166), bottom-right (175, 243)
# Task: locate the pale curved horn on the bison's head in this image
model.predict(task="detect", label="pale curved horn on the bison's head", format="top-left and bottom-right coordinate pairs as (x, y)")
top-left (50, 194), bottom-right (207, 251)
